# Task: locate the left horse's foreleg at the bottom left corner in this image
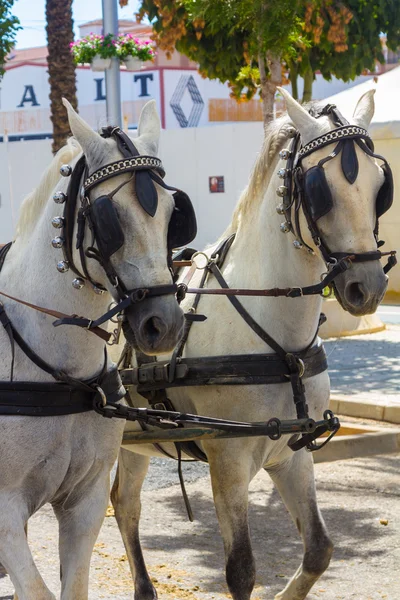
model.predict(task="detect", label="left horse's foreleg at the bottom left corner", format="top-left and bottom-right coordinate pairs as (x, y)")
top-left (0, 510), bottom-right (56, 600)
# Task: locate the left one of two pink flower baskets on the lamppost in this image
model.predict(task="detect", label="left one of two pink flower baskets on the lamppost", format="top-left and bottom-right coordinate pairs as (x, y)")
top-left (70, 33), bottom-right (118, 71)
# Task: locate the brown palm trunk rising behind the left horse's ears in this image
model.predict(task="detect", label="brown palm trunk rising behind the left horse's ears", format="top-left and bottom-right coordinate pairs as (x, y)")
top-left (46, 0), bottom-right (77, 153)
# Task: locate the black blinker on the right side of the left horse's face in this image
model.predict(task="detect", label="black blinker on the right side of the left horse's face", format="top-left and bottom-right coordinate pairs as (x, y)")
top-left (168, 190), bottom-right (197, 248)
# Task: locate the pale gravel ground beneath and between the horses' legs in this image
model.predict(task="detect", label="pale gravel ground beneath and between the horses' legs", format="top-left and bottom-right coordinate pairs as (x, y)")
top-left (0, 455), bottom-right (400, 600)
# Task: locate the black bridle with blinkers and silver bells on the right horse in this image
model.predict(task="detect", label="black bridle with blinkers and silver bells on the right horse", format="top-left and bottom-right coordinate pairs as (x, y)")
top-left (276, 104), bottom-right (396, 273)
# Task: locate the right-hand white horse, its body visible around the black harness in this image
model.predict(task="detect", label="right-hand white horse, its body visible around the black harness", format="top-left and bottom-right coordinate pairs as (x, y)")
top-left (112, 90), bottom-right (387, 600)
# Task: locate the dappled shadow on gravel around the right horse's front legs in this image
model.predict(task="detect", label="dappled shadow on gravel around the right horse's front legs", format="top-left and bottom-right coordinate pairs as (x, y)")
top-left (141, 458), bottom-right (399, 598)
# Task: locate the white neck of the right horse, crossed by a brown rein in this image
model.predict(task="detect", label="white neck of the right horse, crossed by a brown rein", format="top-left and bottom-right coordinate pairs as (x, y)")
top-left (225, 159), bottom-right (324, 351)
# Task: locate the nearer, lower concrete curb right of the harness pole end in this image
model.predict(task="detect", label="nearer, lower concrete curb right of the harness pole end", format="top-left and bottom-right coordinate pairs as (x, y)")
top-left (313, 423), bottom-right (400, 463)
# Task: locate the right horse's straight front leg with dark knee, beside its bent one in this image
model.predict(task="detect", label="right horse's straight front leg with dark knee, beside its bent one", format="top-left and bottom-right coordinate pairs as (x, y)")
top-left (209, 453), bottom-right (256, 600)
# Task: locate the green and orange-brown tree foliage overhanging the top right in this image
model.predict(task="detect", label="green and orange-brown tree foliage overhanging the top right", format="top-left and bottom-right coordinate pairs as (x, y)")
top-left (120, 0), bottom-right (400, 117)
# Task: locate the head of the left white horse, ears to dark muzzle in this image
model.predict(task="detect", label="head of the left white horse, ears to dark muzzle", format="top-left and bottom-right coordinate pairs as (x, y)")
top-left (64, 101), bottom-right (184, 354)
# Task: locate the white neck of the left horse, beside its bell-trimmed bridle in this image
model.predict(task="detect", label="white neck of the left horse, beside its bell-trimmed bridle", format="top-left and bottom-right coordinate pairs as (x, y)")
top-left (0, 181), bottom-right (111, 378)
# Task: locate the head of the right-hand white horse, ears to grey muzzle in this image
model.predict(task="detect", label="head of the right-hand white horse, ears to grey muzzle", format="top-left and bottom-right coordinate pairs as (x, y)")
top-left (280, 89), bottom-right (389, 315)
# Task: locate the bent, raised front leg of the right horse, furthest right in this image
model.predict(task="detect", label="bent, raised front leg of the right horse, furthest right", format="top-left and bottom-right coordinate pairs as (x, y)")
top-left (266, 450), bottom-right (333, 600)
